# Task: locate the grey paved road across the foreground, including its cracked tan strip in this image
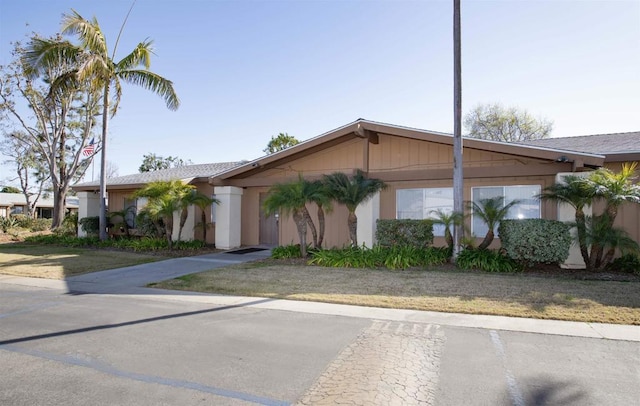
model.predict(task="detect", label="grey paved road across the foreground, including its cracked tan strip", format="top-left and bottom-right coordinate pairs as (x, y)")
top-left (0, 283), bottom-right (640, 406)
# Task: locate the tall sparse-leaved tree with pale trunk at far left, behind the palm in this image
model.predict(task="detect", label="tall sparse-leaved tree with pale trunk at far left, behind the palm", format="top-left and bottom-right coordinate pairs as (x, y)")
top-left (0, 36), bottom-right (99, 229)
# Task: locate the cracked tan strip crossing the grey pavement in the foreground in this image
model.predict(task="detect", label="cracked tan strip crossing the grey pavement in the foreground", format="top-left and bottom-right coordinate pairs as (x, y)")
top-left (298, 321), bottom-right (445, 406)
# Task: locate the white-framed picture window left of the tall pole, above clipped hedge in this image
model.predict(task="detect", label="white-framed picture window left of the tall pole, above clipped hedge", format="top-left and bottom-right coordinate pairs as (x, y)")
top-left (396, 187), bottom-right (453, 237)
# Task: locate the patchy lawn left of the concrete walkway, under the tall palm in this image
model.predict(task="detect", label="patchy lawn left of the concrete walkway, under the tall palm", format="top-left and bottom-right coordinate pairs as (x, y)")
top-left (0, 243), bottom-right (163, 279)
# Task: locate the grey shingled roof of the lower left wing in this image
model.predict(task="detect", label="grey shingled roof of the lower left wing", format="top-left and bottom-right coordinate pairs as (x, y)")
top-left (72, 161), bottom-right (245, 190)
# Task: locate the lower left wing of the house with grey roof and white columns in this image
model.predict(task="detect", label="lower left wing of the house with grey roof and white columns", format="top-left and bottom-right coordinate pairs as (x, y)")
top-left (72, 162), bottom-right (244, 244)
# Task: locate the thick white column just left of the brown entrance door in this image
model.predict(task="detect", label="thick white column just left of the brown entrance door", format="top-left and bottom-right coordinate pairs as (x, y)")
top-left (213, 186), bottom-right (242, 250)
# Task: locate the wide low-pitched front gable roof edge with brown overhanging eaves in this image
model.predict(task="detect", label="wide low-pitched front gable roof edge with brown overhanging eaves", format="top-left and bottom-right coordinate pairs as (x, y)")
top-left (210, 119), bottom-right (604, 183)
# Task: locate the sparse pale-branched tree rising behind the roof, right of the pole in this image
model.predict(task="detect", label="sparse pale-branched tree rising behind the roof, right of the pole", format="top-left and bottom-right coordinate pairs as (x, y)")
top-left (464, 103), bottom-right (553, 142)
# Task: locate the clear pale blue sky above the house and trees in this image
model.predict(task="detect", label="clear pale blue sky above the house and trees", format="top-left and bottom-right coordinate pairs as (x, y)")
top-left (0, 0), bottom-right (640, 182)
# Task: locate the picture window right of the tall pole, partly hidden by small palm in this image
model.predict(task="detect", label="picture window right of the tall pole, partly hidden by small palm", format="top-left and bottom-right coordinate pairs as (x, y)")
top-left (471, 185), bottom-right (540, 237)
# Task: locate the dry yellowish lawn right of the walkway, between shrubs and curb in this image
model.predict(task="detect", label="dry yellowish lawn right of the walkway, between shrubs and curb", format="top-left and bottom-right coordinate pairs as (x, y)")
top-left (153, 262), bottom-right (640, 325)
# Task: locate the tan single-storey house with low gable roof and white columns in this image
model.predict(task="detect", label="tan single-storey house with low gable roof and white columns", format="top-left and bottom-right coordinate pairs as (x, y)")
top-left (73, 119), bottom-right (640, 266)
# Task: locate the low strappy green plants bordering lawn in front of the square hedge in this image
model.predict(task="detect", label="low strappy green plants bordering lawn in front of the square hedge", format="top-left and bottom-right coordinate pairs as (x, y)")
top-left (309, 245), bottom-right (449, 269)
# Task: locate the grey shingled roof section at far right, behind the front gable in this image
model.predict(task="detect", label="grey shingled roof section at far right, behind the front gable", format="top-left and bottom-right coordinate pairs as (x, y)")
top-left (525, 131), bottom-right (640, 161)
